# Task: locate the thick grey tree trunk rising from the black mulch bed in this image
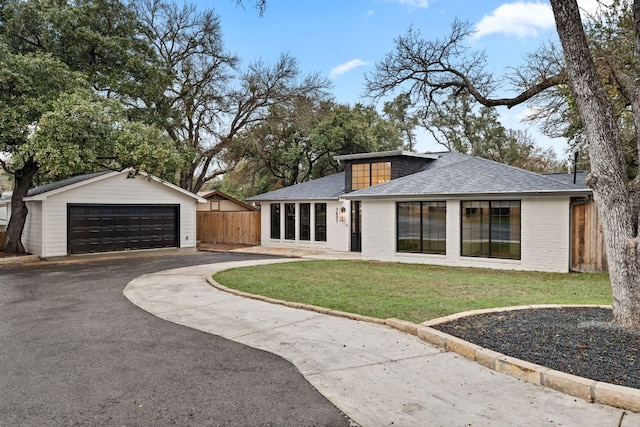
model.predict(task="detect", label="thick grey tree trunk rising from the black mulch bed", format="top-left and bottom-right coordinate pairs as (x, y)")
top-left (551, 0), bottom-right (640, 329)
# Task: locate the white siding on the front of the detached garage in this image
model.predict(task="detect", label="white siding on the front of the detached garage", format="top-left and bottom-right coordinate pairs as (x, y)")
top-left (29, 174), bottom-right (196, 257)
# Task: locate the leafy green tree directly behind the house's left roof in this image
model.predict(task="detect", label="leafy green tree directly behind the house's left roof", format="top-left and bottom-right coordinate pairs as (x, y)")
top-left (217, 102), bottom-right (402, 198)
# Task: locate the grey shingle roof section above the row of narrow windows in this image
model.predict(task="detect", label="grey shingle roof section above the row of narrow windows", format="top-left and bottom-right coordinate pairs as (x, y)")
top-left (247, 172), bottom-right (344, 202)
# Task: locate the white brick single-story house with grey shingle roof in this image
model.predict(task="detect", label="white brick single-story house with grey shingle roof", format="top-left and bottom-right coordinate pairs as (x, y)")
top-left (248, 151), bottom-right (592, 272)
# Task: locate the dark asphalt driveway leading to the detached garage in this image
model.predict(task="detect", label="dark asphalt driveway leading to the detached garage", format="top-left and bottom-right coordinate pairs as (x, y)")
top-left (0, 253), bottom-right (349, 426)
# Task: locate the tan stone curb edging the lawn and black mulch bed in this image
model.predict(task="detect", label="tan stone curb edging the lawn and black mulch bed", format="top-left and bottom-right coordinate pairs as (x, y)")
top-left (207, 276), bottom-right (640, 412)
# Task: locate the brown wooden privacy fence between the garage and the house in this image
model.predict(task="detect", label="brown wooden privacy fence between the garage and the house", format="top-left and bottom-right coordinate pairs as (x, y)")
top-left (196, 211), bottom-right (260, 245)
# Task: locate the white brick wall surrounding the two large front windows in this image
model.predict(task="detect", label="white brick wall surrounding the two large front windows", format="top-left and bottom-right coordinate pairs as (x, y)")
top-left (362, 197), bottom-right (569, 272)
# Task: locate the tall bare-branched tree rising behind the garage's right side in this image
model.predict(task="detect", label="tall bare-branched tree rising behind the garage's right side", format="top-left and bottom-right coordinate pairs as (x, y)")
top-left (135, 0), bottom-right (328, 192)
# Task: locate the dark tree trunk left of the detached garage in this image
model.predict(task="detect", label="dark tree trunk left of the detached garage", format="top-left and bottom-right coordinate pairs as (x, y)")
top-left (2, 158), bottom-right (39, 254)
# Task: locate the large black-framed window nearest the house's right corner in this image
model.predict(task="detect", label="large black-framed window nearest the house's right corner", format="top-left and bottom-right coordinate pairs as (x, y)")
top-left (462, 201), bottom-right (520, 259)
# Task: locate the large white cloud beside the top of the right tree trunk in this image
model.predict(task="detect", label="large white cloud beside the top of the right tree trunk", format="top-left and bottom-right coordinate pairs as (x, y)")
top-left (475, 1), bottom-right (555, 38)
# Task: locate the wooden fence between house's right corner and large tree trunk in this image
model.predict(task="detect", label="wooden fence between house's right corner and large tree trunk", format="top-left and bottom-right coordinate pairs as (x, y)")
top-left (571, 201), bottom-right (609, 272)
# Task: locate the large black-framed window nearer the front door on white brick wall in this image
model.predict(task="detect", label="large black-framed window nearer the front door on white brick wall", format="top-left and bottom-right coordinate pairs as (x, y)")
top-left (397, 202), bottom-right (447, 254)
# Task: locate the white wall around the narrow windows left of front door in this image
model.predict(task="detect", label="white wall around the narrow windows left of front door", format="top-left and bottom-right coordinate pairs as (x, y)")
top-left (260, 200), bottom-right (350, 251)
